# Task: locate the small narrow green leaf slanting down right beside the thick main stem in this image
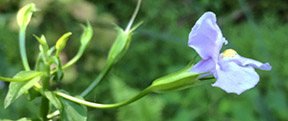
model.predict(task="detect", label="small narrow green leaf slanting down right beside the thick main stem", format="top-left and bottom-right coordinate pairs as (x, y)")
top-left (44, 91), bottom-right (62, 110)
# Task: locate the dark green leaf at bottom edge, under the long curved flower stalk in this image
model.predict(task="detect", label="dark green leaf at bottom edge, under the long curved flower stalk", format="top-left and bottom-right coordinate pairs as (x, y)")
top-left (60, 97), bottom-right (87, 121)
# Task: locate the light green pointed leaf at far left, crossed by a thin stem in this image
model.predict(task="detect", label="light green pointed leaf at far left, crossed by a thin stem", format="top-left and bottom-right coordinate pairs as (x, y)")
top-left (4, 71), bottom-right (41, 108)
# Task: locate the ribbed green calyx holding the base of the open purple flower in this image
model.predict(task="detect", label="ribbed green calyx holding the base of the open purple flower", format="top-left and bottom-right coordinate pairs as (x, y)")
top-left (149, 62), bottom-right (203, 93)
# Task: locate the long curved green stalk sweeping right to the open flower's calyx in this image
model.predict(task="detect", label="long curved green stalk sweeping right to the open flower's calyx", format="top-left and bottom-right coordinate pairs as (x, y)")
top-left (56, 88), bottom-right (151, 109)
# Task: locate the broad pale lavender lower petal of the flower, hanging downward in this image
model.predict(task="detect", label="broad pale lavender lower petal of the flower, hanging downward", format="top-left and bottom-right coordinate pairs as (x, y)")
top-left (212, 60), bottom-right (259, 95)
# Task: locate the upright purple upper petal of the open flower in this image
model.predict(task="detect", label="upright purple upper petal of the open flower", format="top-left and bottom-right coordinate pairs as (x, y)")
top-left (188, 12), bottom-right (227, 60)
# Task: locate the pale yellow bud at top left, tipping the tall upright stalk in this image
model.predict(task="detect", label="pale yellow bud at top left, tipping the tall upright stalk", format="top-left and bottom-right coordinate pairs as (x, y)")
top-left (17, 3), bottom-right (36, 27)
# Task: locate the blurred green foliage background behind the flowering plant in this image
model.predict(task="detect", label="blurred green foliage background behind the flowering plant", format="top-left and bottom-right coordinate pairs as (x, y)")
top-left (0, 0), bottom-right (288, 121)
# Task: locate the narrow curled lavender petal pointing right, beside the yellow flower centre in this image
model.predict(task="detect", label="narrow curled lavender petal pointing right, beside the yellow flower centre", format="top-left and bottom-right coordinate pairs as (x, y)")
top-left (225, 55), bottom-right (272, 71)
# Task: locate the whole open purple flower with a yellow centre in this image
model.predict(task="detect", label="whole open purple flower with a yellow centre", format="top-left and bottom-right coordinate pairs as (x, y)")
top-left (188, 12), bottom-right (271, 95)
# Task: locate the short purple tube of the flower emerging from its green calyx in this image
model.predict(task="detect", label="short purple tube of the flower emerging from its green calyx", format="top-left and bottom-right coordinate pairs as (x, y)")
top-left (189, 58), bottom-right (216, 73)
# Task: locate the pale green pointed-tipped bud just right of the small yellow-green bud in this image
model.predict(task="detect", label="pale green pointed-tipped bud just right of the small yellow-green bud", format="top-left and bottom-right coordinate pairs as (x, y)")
top-left (81, 21), bottom-right (93, 46)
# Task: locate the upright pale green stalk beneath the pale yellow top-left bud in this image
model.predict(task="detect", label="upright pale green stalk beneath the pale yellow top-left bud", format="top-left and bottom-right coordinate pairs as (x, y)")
top-left (19, 27), bottom-right (31, 71)
